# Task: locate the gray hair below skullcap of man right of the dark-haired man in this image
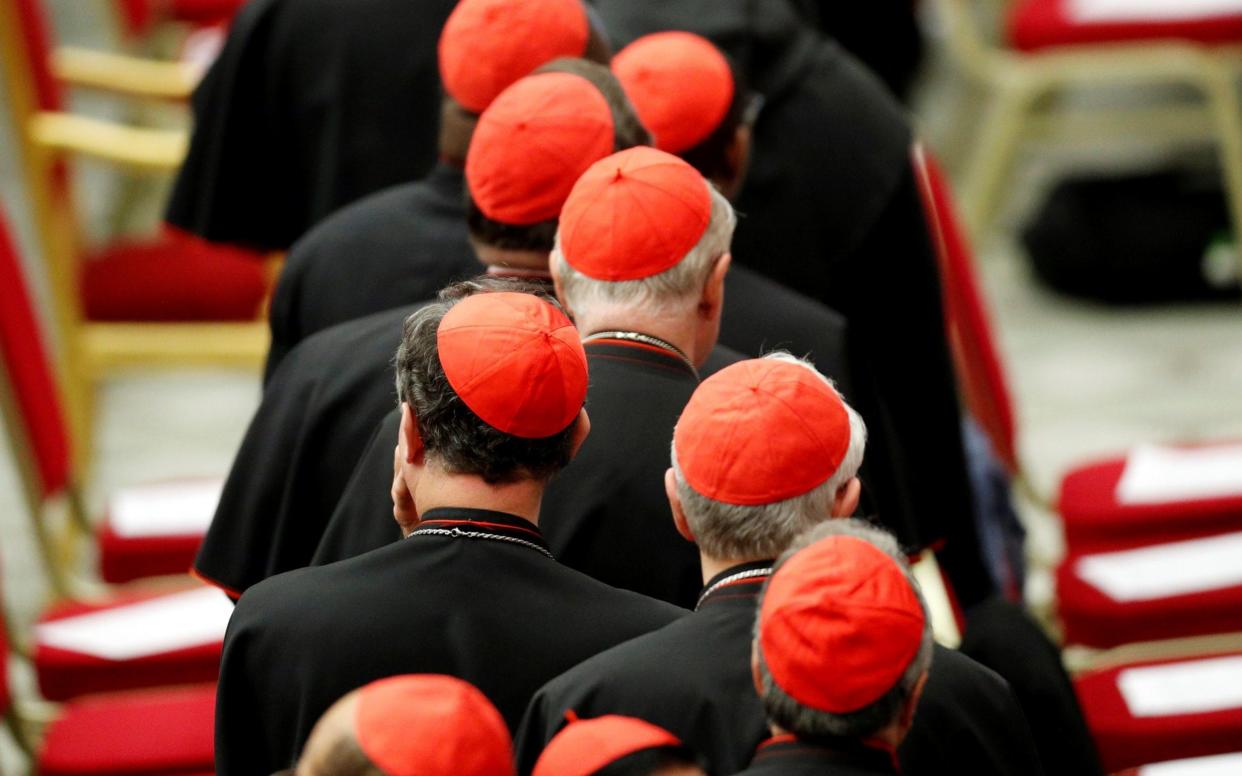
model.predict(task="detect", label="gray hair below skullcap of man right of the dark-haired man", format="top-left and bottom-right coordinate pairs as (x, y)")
top-left (672, 350), bottom-right (867, 559)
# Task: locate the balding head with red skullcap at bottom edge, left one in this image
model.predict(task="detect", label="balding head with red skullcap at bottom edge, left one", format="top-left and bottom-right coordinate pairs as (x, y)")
top-left (297, 674), bottom-right (513, 776)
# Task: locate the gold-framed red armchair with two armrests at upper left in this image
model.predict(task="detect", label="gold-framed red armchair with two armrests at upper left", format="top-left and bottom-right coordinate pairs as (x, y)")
top-left (0, 0), bottom-right (272, 469)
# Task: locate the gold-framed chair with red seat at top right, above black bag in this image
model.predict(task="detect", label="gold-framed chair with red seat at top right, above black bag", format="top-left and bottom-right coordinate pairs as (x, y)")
top-left (939, 0), bottom-right (1242, 254)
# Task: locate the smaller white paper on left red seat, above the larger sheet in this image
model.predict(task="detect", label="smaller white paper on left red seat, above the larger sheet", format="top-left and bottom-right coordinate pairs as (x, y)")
top-left (108, 479), bottom-right (224, 538)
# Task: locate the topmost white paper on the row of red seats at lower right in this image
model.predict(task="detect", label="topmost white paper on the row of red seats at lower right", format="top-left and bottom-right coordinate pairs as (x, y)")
top-left (1117, 444), bottom-right (1242, 504)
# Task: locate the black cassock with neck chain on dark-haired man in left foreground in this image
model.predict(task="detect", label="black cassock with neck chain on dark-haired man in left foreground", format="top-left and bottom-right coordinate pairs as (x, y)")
top-left (216, 509), bottom-right (686, 776)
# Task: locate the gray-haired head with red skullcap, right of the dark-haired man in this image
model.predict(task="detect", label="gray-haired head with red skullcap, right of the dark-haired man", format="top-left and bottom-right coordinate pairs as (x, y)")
top-left (672, 353), bottom-right (867, 559)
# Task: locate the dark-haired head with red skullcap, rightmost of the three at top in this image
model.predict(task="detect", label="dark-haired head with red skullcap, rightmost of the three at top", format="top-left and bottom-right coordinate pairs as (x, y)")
top-left (612, 31), bottom-right (758, 185)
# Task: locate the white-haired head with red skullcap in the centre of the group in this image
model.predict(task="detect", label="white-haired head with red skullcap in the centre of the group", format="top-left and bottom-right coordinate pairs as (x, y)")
top-left (550, 147), bottom-right (735, 314)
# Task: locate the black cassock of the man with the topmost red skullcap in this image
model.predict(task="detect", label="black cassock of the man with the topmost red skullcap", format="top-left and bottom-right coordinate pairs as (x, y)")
top-left (267, 161), bottom-right (479, 376)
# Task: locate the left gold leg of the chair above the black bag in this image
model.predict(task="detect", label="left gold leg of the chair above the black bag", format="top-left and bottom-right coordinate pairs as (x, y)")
top-left (961, 84), bottom-right (1033, 245)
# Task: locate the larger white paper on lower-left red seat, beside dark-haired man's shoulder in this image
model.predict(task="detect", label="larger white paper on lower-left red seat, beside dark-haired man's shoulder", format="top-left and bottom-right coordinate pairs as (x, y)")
top-left (35, 587), bottom-right (232, 661)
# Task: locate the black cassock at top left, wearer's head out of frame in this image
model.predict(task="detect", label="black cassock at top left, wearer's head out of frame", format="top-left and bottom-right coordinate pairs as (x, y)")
top-left (165, 0), bottom-right (456, 250)
